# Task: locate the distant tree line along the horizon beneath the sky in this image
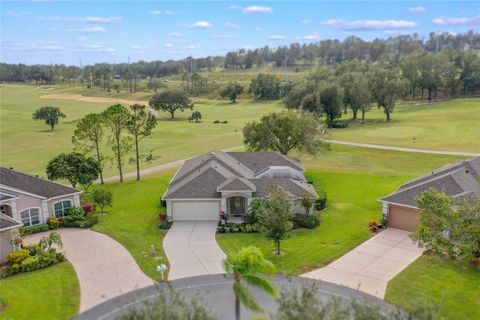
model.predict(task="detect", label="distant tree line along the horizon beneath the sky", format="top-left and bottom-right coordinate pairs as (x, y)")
top-left (0, 31), bottom-right (480, 85)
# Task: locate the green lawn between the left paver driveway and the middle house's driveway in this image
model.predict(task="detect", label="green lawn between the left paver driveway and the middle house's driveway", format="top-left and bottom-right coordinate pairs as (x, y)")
top-left (93, 171), bottom-right (173, 279)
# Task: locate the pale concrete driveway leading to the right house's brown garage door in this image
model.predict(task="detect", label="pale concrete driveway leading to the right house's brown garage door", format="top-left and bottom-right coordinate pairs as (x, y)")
top-left (302, 228), bottom-right (423, 299)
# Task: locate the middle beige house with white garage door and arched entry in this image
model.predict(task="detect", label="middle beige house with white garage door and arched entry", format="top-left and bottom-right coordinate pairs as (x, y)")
top-left (162, 151), bottom-right (318, 221)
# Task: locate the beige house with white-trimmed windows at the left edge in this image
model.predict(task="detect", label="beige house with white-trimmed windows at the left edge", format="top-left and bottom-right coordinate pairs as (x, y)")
top-left (0, 167), bottom-right (81, 227)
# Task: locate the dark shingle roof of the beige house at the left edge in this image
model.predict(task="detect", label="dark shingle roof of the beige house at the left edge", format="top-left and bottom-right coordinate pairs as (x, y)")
top-left (0, 167), bottom-right (80, 199)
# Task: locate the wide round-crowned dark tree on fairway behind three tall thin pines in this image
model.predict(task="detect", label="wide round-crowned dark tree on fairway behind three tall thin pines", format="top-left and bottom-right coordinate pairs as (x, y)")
top-left (148, 90), bottom-right (193, 119)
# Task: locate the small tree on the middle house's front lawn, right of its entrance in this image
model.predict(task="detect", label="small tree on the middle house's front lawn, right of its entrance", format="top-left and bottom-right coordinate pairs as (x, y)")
top-left (258, 185), bottom-right (293, 255)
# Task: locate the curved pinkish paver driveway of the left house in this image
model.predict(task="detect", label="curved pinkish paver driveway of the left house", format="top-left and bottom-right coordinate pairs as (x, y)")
top-left (25, 228), bottom-right (154, 312)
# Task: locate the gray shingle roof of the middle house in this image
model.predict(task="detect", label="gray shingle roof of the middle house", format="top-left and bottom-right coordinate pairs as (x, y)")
top-left (162, 151), bottom-right (317, 199)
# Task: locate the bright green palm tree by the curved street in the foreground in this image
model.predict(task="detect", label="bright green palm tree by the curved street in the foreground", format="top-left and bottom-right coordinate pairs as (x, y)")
top-left (223, 246), bottom-right (278, 320)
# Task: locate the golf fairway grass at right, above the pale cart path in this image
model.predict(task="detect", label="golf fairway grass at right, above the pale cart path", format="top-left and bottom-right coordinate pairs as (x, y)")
top-left (329, 99), bottom-right (480, 152)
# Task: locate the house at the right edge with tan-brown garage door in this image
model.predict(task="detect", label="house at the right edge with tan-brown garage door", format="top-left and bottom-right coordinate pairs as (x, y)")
top-left (379, 158), bottom-right (480, 231)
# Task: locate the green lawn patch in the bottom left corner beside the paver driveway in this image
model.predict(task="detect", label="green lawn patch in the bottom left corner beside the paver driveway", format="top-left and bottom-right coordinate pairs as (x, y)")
top-left (0, 262), bottom-right (80, 320)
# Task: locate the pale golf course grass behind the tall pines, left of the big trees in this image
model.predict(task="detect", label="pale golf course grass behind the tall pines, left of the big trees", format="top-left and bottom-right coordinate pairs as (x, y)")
top-left (0, 85), bottom-right (281, 176)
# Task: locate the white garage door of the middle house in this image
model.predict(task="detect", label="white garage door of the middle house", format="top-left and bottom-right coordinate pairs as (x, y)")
top-left (172, 200), bottom-right (220, 221)
